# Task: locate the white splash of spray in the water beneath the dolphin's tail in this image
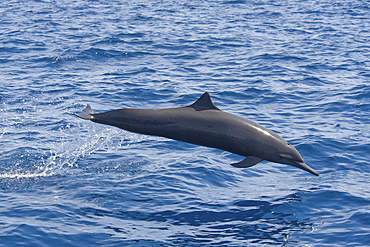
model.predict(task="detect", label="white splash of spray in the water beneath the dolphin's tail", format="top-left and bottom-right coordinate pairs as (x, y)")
top-left (0, 120), bottom-right (131, 179)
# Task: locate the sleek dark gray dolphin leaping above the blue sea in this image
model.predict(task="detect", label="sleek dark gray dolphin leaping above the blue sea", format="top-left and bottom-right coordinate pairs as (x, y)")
top-left (75, 92), bottom-right (319, 176)
